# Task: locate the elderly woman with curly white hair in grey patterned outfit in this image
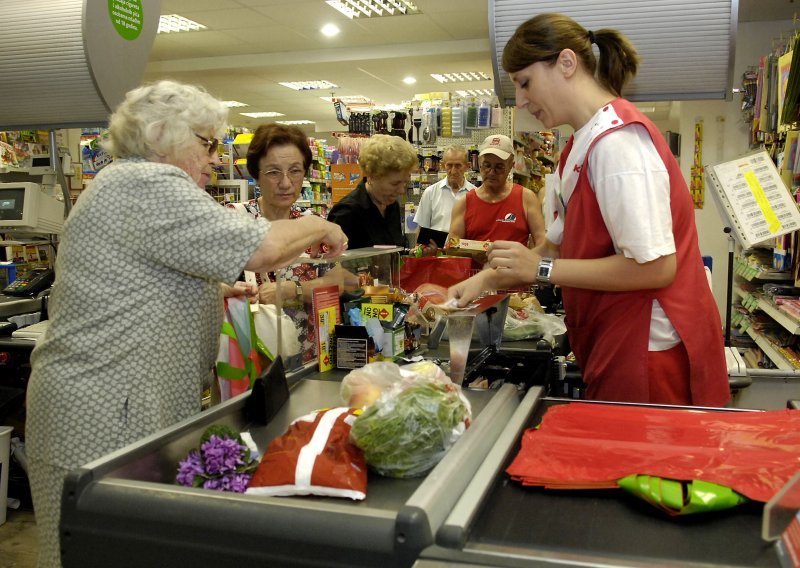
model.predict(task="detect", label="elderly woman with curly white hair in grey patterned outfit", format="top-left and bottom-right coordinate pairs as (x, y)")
top-left (25, 81), bottom-right (347, 566)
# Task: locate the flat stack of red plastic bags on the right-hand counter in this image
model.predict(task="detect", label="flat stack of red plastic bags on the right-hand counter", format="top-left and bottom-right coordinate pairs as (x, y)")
top-left (506, 403), bottom-right (800, 501)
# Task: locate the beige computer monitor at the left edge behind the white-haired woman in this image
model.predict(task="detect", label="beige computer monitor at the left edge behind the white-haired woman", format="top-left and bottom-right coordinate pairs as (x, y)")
top-left (0, 182), bottom-right (64, 234)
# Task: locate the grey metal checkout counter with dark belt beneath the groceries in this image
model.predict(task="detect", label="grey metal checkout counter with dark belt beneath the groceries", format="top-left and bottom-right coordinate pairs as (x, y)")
top-left (57, 296), bottom-right (779, 568)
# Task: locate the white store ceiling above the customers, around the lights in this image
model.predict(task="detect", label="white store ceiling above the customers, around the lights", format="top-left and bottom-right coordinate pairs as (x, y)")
top-left (145, 0), bottom-right (800, 133)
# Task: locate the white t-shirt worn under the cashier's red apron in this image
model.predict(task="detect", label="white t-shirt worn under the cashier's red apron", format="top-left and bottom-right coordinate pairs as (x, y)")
top-left (546, 104), bottom-right (680, 351)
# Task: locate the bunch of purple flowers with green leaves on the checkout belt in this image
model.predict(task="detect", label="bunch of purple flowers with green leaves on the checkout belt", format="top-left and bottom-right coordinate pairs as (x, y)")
top-left (175, 424), bottom-right (258, 493)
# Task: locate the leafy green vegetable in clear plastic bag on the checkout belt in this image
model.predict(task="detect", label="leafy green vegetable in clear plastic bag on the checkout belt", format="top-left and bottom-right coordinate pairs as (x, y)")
top-left (350, 379), bottom-right (470, 477)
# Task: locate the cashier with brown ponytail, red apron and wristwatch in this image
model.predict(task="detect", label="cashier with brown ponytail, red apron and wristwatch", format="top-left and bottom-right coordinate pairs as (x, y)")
top-left (450, 14), bottom-right (729, 406)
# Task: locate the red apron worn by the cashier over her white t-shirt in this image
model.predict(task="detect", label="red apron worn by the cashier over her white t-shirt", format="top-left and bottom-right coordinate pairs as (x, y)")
top-left (559, 99), bottom-right (730, 406)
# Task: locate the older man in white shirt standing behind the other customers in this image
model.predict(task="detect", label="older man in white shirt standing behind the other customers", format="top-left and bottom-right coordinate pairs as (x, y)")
top-left (414, 146), bottom-right (475, 247)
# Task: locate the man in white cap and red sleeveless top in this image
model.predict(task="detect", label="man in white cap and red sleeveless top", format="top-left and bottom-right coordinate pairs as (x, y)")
top-left (449, 134), bottom-right (544, 247)
